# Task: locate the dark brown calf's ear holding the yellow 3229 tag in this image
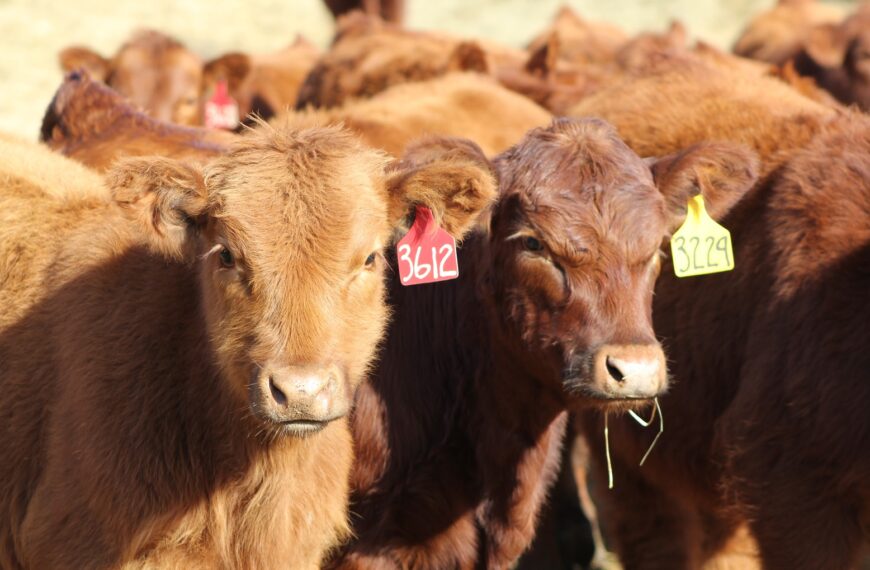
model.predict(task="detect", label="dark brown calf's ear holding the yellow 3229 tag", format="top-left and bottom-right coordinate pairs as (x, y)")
top-left (648, 142), bottom-right (759, 230)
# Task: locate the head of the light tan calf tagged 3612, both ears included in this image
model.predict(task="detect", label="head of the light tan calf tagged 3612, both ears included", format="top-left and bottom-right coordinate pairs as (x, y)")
top-left (113, 125), bottom-right (495, 435)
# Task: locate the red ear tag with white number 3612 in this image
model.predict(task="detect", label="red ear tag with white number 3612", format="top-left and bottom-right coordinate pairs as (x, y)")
top-left (396, 206), bottom-right (459, 285)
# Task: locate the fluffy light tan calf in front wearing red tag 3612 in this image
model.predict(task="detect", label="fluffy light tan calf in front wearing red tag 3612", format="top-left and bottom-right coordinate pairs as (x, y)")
top-left (0, 126), bottom-right (495, 568)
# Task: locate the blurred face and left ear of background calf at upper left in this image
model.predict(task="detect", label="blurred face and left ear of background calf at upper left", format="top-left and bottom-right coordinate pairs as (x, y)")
top-left (59, 30), bottom-right (202, 125)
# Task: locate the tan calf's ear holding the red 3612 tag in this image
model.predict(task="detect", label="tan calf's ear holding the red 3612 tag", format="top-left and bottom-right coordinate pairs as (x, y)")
top-left (387, 137), bottom-right (497, 239)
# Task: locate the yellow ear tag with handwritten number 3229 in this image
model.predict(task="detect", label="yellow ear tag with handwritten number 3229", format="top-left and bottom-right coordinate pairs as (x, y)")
top-left (671, 194), bottom-right (734, 277)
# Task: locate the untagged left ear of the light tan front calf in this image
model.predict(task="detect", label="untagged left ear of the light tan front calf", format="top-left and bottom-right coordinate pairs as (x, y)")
top-left (106, 157), bottom-right (208, 260)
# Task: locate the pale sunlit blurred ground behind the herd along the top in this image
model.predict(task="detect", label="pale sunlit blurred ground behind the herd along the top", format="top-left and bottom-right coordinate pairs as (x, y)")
top-left (0, 0), bottom-right (860, 138)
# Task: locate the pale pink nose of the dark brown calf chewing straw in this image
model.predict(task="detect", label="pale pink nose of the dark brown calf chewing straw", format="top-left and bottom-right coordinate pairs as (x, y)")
top-left (593, 344), bottom-right (667, 398)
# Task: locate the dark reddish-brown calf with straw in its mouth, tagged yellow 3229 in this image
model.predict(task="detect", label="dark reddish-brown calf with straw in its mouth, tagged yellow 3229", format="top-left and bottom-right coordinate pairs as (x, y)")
top-left (329, 119), bottom-right (755, 568)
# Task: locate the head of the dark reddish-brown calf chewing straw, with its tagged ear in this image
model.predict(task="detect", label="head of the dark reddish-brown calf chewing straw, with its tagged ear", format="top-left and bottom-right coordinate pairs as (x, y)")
top-left (487, 119), bottom-right (756, 403)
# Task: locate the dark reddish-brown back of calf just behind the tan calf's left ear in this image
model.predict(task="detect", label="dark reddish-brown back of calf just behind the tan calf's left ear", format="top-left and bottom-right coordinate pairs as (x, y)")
top-left (40, 72), bottom-right (236, 170)
